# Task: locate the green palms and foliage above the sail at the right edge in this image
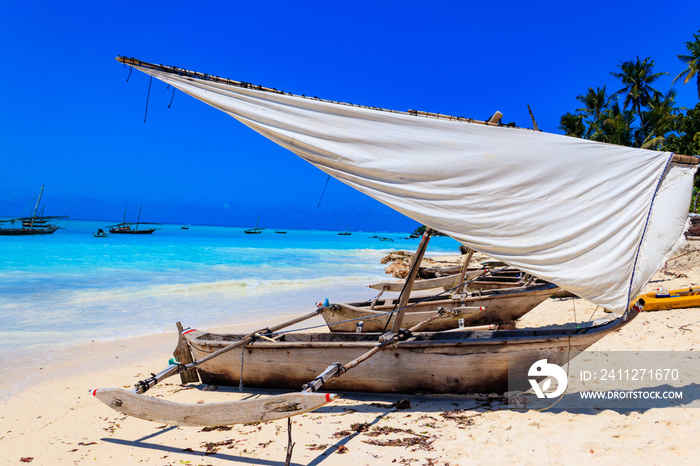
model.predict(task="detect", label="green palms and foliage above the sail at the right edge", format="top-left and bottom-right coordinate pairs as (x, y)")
top-left (559, 31), bottom-right (700, 208)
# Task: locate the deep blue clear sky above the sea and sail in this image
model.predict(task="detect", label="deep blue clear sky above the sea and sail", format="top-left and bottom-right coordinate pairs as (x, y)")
top-left (0, 0), bottom-right (700, 231)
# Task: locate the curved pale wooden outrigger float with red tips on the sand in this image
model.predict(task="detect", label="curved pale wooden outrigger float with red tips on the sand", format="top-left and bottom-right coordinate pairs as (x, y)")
top-left (93, 388), bottom-right (339, 426)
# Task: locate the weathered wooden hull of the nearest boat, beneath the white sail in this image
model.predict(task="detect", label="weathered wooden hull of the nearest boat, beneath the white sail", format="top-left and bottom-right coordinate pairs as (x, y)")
top-left (184, 307), bottom-right (639, 394)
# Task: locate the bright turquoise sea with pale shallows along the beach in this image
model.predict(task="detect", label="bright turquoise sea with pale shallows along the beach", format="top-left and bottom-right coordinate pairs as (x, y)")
top-left (0, 220), bottom-right (458, 354)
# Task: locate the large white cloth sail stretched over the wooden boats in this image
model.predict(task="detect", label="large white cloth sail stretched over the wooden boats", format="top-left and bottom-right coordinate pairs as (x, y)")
top-left (129, 60), bottom-right (695, 311)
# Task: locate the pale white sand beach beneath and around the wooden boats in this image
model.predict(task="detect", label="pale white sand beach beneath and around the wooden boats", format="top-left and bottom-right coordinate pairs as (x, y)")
top-left (0, 245), bottom-right (700, 465)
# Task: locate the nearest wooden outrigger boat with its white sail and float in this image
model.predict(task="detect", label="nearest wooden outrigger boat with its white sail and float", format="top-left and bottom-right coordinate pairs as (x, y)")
top-left (93, 57), bottom-right (698, 434)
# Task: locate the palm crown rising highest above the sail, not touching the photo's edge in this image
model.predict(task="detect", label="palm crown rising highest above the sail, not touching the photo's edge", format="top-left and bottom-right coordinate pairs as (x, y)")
top-left (610, 57), bottom-right (668, 123)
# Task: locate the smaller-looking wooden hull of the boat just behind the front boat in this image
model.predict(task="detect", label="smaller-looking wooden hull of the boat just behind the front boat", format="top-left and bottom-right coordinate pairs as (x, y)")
top-left (321, 283), bottom-right (559, 332)
